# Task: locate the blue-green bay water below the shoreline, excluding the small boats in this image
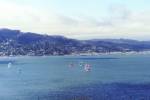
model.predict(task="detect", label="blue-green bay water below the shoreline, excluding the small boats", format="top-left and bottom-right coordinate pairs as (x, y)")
top-left (0, 54), bottom-right (150, 100)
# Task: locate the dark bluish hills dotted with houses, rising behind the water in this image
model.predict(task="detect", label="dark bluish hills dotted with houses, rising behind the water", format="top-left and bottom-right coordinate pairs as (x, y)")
top-left (0, 29), bottom-right (150, 56)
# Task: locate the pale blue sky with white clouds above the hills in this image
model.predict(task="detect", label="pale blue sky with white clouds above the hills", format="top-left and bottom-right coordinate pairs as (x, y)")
top-left (0, 0), bottom-right (150, 40)
